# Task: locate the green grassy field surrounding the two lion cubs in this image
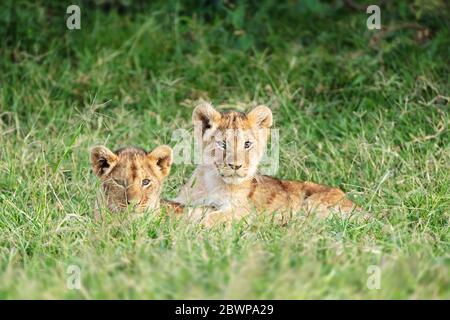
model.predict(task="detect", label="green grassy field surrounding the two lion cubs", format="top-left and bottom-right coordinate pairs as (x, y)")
top-left (0, 0), bottom-right (450, 299)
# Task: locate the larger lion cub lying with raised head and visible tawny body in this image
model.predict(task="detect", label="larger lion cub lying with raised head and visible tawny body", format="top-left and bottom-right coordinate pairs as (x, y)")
top-left (175, 102), bottom-right (360, 223)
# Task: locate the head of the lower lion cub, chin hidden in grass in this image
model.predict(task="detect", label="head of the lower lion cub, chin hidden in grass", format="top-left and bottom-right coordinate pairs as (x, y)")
top-left (91, 146), bottom-right (172, 212)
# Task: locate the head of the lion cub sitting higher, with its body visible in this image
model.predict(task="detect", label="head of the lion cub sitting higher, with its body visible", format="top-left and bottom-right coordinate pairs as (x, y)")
top-left (192, 102), bottom-right (272, 184)
